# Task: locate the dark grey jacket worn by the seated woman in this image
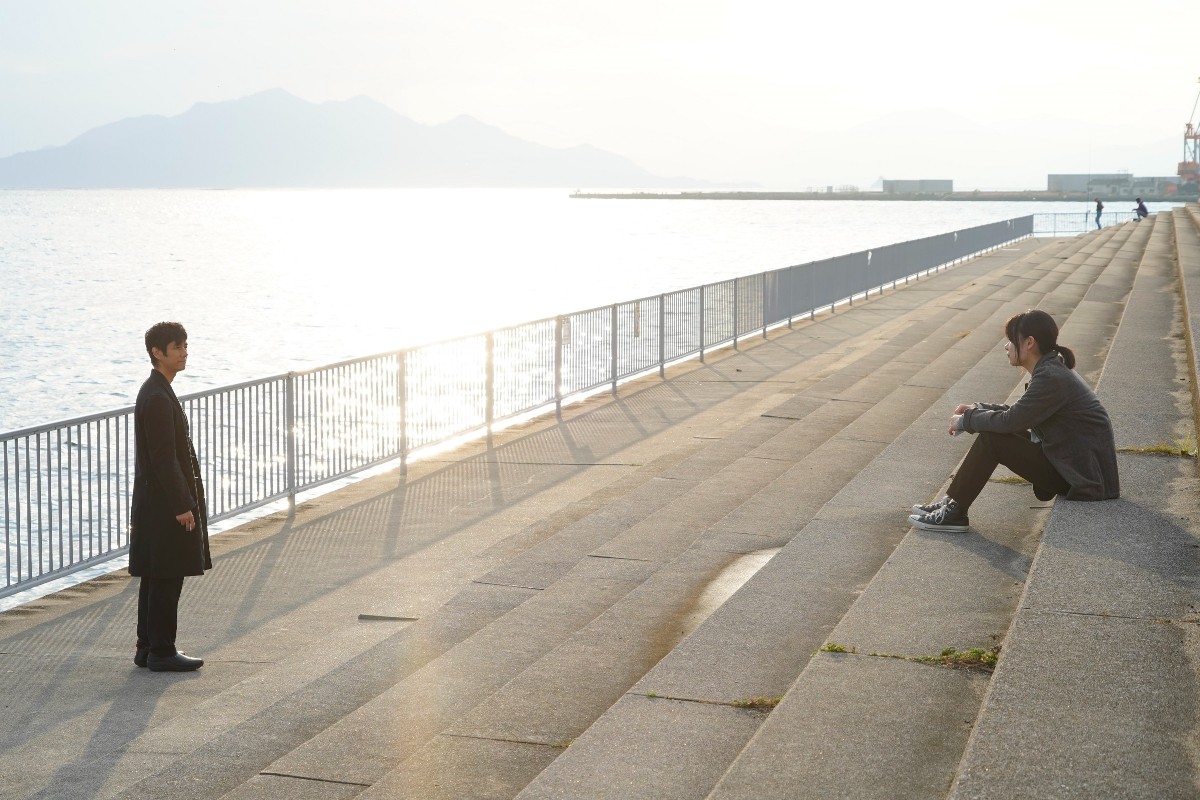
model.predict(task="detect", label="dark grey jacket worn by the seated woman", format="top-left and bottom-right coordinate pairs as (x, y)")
top-left (962, 353), bottom-right (1121, 500)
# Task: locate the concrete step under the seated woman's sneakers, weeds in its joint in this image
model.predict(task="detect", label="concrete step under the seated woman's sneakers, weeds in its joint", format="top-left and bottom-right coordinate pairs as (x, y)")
top-left (712, 221), bottom-right (1139, 798)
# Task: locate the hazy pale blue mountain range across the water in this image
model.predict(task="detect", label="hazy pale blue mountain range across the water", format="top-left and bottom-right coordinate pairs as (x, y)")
top-left (0, 89), bottom-right (706, 188)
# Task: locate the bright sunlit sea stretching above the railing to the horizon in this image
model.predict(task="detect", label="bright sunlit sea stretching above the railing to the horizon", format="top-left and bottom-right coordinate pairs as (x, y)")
top-left (0, 190), bottom-right (1171, 432)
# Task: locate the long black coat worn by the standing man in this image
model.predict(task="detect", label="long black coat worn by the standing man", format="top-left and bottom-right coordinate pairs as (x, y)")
top-left (130, 371), bottom-right (212, 578)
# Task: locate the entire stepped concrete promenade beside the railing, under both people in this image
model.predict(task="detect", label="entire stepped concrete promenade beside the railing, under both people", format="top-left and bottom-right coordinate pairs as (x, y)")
top-left (0, 205), bottom-right (1200, 800)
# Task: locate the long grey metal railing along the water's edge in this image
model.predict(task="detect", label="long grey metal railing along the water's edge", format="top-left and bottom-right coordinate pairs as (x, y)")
top-left (0, 216), bottom-right (1033, 597)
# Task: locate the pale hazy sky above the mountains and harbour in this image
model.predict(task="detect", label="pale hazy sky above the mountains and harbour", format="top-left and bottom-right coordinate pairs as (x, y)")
top-left (0, 0), bottom-right (1200, 188)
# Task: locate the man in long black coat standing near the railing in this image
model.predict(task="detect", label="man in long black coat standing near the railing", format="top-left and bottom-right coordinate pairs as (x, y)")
top-left (130, 323), bottom-right (212, 672)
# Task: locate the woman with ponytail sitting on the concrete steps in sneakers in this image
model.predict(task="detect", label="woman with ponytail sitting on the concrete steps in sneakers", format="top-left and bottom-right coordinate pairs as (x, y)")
top-left (908, 311), bottom-right (1121, 531)
